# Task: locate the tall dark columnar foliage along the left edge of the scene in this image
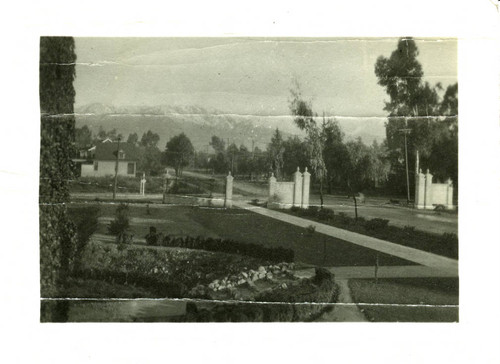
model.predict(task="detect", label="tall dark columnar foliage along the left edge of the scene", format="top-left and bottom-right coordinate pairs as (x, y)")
top-left (39, 37), bottom-right (76, 321)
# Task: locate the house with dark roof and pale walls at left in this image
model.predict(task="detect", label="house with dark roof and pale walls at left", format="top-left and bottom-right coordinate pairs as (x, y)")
top-left (81, 141), bottom-right (139, 177)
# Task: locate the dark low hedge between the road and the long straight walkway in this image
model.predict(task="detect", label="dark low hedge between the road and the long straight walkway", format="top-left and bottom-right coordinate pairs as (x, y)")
top-left (289, 206), bottom-right (458, 259)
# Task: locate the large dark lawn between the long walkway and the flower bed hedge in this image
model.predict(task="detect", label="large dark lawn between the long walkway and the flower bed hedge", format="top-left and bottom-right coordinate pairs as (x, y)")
top-left (85, 204), bottom-right (413, 266)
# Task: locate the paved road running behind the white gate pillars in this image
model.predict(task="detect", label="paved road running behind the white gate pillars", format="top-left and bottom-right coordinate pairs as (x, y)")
top-left (184, 171), bottom-right (458, 234)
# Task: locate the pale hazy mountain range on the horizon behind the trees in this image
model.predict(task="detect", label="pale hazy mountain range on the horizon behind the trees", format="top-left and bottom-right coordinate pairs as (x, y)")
top-left (75, 103), bottom-right (385, 150)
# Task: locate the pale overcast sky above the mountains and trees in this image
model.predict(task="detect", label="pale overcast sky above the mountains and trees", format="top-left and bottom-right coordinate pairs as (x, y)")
top-left (75, 38), bottom-right (457, 117)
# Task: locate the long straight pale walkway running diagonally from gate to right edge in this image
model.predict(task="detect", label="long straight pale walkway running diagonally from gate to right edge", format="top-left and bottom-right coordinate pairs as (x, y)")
top-left (233, 201), bottom-right (458, 276)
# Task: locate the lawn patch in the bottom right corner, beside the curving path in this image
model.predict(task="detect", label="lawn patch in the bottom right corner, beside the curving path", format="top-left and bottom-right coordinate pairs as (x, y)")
top-left (349, 278), bottom-right (458, 322)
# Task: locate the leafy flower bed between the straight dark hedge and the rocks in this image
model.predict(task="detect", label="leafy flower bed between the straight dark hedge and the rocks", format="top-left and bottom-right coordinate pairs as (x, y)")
top-left (75, 242), bottom-right (267, 297)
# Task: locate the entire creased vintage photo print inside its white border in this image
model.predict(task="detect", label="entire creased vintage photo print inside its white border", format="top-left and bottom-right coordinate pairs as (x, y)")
top-left (39, 34), bottom-right (459, 323)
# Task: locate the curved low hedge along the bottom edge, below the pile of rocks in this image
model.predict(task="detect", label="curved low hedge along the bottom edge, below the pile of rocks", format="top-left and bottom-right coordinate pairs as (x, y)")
top-left (186, 268), bottom-right (338, 322)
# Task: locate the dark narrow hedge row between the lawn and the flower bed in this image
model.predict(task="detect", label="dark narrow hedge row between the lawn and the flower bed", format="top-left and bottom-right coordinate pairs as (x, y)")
top-left (146, 229), bottom-right (295, 263)
